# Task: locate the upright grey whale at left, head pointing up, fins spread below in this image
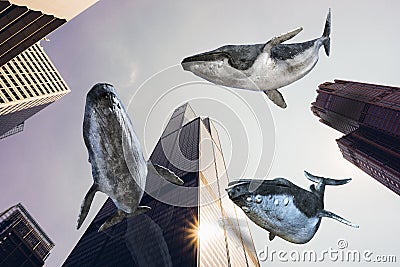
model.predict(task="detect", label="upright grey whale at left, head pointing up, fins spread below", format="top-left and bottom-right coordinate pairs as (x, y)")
top-left (77, 83), bottom-right (183, 231)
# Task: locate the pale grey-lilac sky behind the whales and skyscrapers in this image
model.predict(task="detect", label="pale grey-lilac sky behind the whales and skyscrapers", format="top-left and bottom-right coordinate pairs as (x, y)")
top-left (0, 0), bottom-right (400, 266)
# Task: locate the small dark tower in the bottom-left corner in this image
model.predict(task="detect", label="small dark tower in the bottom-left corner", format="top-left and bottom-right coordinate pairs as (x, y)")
top-left (0, 204), bottom-right (54, 267)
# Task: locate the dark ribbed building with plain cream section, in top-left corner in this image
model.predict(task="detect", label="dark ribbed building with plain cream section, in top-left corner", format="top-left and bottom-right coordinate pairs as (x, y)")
top-left (0, 0), bottom-right (98, 66)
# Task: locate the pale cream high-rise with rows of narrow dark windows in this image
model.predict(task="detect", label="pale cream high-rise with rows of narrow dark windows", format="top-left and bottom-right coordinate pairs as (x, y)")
top-left (0, 43), bottom-right (70, 139)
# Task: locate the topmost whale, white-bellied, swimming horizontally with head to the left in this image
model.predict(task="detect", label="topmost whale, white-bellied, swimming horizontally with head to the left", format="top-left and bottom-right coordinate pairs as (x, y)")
top-left (181, 9), bottom-right (331, 108)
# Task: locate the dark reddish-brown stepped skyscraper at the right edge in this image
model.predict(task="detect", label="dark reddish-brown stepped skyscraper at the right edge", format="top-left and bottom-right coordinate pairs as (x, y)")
top-left (311, 80), bottom-right (400, 195)
